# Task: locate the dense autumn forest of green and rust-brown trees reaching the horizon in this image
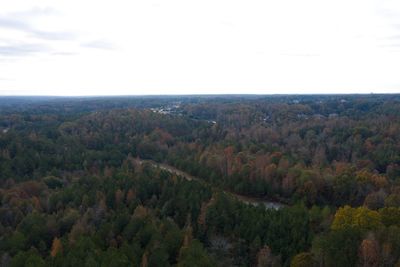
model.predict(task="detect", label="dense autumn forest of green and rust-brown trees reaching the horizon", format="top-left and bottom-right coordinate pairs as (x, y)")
top-left (0, 94), bottom-right (400, 267)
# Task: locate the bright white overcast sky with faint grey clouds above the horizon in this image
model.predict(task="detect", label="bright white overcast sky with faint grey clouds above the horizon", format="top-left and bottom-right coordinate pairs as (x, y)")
top-left (0, 0), bottom-right (400, 96)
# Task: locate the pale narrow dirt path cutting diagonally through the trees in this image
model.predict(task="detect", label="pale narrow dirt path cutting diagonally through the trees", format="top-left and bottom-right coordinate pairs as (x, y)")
top-left (139, 160), bottom-right (285, 210)
